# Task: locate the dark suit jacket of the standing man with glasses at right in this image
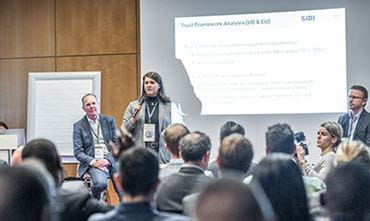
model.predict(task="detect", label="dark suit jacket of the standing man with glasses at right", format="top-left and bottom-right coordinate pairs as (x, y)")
top-left (338, 109), bottom-right (370, 146)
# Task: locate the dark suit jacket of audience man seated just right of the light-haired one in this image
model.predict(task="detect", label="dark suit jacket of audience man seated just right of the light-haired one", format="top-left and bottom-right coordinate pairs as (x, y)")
top-left (156, 166), bottom-right (212, 213)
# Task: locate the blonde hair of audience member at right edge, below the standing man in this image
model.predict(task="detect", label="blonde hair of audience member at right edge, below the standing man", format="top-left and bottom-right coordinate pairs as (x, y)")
top-left (337, 140), bottom-right (370, 163)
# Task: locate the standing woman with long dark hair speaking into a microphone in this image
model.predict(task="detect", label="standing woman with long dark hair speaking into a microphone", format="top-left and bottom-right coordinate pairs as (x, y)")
top-left (121, 72), bottom-right (179, 164)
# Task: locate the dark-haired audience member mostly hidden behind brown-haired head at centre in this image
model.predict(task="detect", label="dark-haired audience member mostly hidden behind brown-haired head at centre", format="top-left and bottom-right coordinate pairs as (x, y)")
top-left (208, 121), bottom-right (245, 178)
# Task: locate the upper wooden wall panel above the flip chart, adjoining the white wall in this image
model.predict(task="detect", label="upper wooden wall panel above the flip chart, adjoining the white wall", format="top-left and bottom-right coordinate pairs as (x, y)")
top-left (56, 0), bottom-right (137, 56)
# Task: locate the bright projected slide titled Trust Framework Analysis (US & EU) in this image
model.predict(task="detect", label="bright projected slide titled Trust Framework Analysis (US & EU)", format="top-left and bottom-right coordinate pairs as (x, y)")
top-left (175, 8), bottom-right (347, 115)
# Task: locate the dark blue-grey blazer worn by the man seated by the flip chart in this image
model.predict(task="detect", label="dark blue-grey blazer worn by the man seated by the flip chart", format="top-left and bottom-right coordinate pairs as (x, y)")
top-left (73, 114), bottom-right (117, 176)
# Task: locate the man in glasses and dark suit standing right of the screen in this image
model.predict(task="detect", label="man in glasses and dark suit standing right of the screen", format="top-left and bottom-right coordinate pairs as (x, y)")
top-left (338, 85), bottom-right (370, 146)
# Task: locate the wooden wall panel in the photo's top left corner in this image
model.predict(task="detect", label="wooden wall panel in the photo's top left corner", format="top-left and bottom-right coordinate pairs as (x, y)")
top-left (0, 0), bottom-right (55, 58)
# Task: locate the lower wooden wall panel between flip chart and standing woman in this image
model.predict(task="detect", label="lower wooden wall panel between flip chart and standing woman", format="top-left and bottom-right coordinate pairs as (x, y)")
top-left (57, 55), bottom-right (138, 126)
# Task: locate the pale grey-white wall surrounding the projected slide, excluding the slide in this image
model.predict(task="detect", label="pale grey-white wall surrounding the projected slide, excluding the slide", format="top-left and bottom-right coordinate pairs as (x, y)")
top-left (141, 0), bottom-right (370, 161)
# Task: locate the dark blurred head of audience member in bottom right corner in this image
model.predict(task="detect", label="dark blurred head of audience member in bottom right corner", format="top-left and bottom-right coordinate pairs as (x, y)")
top-left (324, 162), bottom-right (370, 221)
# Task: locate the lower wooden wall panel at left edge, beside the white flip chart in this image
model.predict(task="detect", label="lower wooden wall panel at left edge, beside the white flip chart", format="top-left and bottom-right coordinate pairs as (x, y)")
top-left (0, 58), bottom-right (55, 128)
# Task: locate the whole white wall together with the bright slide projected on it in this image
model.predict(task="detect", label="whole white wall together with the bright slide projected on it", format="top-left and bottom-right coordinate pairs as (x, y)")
top-left (140, 0), bottom-right (370, 162)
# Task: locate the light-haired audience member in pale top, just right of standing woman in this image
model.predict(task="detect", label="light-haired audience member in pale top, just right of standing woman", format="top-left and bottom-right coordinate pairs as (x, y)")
top-left (159, 123), bottom-right (189, 179)
